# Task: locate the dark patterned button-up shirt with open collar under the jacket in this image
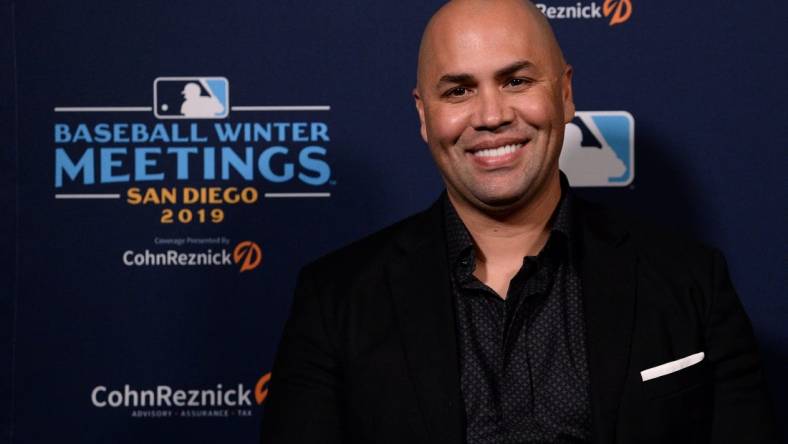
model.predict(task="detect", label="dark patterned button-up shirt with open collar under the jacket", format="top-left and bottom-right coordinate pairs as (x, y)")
top-left (444, 192), bottom-right (591, 444)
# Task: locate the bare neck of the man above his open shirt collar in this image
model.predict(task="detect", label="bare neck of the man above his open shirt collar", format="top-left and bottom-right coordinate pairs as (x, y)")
top-left (449, 176), bottom-right (561, 298)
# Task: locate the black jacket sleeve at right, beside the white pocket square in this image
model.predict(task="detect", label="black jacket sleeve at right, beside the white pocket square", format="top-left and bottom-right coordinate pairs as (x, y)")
top-left (706, 250), bottom-right (777, 443)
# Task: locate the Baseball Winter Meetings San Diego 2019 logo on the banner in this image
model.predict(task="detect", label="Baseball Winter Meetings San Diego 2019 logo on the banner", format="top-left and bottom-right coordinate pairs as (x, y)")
top-left (52, 76), bottom-right (336, 226)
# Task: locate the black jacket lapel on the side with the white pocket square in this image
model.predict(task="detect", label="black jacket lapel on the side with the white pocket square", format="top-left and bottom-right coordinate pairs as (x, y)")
top-left (579, 205), bottom-right (636, 443)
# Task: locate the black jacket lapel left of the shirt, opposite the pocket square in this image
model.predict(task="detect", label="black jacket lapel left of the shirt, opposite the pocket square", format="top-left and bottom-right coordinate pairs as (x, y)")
top-left (388, 200), bottom-right (464, 443)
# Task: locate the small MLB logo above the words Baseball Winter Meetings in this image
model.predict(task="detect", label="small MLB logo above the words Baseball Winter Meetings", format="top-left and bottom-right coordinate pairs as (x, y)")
top-left (153, 77), bottom-right (230, 119)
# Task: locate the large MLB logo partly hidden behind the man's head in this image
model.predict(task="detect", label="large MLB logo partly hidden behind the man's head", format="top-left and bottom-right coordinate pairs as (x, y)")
top-left (559, 111), bottom-right (635, 187)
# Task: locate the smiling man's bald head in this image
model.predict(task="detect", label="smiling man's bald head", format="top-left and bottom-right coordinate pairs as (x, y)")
top-left (413, 0), bottom-right (575, 213)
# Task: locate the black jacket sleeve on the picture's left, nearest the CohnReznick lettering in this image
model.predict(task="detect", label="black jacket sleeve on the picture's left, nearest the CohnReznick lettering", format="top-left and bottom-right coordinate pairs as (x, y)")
top-left (260, 270), bottom-right (343, 444)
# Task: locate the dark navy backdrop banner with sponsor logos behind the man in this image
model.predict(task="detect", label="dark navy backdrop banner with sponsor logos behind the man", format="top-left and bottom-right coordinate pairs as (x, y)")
top-left (0, 0), bottom-right (788, 444)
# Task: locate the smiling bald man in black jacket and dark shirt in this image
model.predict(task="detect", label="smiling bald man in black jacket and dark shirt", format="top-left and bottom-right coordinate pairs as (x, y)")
top-left (262, 0), bottom-right (775, 443)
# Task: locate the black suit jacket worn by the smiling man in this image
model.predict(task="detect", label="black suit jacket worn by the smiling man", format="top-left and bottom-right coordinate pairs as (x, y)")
top-left (262, 199), bottom-right (776, 444)
